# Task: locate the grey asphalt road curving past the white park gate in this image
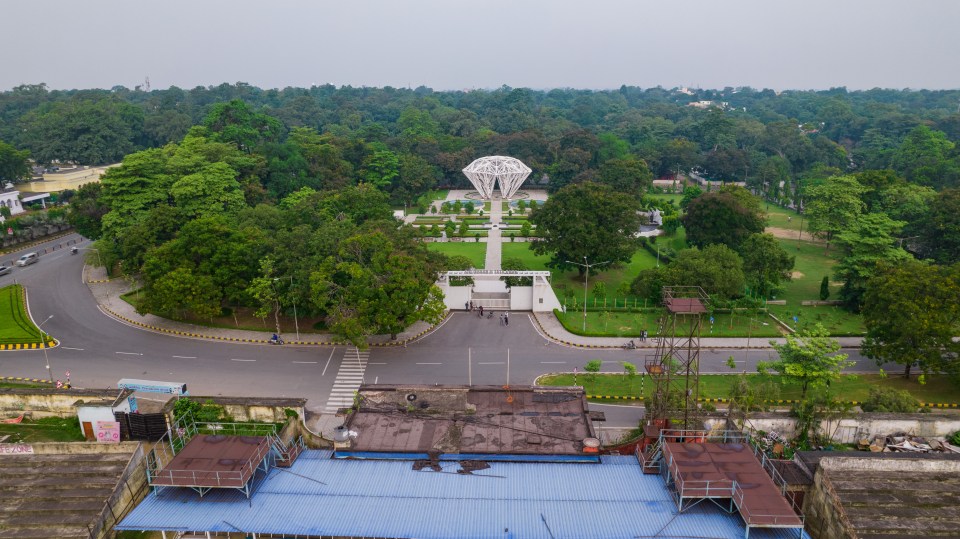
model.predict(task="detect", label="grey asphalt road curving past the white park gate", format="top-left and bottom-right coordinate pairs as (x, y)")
top-left (0, 235), bottom-right (877, 426)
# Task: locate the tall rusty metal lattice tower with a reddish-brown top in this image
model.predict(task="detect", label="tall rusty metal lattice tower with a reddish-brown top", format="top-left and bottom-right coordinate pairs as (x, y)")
top-left (644, 286), bottom-right (710, 429)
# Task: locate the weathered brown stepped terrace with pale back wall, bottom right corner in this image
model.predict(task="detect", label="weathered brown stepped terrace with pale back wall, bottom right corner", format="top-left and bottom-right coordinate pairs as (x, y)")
top-left (800, 453), bottom-right (960, 539)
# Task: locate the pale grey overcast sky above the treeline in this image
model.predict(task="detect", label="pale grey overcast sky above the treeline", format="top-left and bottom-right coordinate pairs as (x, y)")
top-left (0, 0), bottom-right (960, 90)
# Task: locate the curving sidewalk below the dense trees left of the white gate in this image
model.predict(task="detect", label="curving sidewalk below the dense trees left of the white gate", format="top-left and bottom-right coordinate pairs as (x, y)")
top-left (83, 266), bottom-right (434, 346)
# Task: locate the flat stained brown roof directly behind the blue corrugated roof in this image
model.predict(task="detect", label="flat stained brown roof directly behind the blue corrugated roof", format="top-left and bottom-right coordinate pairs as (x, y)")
top-left (346, 385), bottom-right (594, 455)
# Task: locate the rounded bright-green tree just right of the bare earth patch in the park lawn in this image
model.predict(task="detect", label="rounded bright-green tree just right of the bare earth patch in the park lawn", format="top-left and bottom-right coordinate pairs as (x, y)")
top-left (804, 176), bottom-right (865, 250)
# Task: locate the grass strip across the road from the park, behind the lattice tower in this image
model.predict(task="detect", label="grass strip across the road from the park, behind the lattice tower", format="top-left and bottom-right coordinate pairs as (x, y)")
top-left (539, 376), bottom-right (960, 403)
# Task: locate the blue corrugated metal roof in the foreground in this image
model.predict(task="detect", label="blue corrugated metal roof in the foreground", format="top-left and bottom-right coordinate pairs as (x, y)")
top-left (117, 451), bottom-right (797, 539)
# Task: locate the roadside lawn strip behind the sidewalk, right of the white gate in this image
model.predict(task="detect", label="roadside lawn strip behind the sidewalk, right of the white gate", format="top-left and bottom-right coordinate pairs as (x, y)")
top-left (557, 308), bottom-right (782, 338)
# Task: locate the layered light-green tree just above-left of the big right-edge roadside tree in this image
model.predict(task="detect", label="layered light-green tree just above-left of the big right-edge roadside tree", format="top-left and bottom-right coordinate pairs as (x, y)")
top-left (833, 213), bottom-right (913, 311)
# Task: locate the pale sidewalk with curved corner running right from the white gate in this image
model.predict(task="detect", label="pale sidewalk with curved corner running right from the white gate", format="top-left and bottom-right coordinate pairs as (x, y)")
top-left (533, 313), bottom-right (863, 350)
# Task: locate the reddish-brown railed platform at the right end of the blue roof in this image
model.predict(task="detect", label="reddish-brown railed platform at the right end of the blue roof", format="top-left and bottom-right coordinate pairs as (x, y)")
top-left (663, 442), bottom-right (803, 528)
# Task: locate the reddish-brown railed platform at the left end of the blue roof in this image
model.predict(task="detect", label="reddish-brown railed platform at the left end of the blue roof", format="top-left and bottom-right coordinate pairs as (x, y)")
top-left (150, 434), bottom-right (271, 492)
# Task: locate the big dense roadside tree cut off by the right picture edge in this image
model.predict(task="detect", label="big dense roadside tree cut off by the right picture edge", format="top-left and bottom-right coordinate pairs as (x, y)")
top-left (862, 262), bottom-right (960, 377)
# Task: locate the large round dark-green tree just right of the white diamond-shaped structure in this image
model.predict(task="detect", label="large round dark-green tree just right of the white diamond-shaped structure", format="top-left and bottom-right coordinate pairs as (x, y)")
top-left (530, 182), bottom-right (640, 275)
